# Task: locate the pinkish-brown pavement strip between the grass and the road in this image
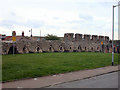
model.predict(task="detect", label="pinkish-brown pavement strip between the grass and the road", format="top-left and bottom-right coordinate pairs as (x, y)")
top-left (2, 66), bottom-right (118, 88)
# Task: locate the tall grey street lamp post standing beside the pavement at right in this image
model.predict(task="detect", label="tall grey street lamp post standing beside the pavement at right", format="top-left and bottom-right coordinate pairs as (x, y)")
top-left (112, 4), bottom-right (120, 66)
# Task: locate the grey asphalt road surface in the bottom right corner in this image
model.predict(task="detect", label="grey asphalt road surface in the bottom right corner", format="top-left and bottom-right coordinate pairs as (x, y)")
top-left (48, 72), bottom-right (118, 88)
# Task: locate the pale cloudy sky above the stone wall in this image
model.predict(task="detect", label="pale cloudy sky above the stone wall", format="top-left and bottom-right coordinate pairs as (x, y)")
top-left (0, 0), bottom-right (119, 39)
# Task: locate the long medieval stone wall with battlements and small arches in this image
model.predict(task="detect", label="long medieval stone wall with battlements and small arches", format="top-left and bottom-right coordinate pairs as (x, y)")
top-left (2, 33), bottom-right (117, 54)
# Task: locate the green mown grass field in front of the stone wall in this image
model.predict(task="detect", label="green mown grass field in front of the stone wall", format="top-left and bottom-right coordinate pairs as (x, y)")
top-left (2, 52), bottom-right (118, 81)
